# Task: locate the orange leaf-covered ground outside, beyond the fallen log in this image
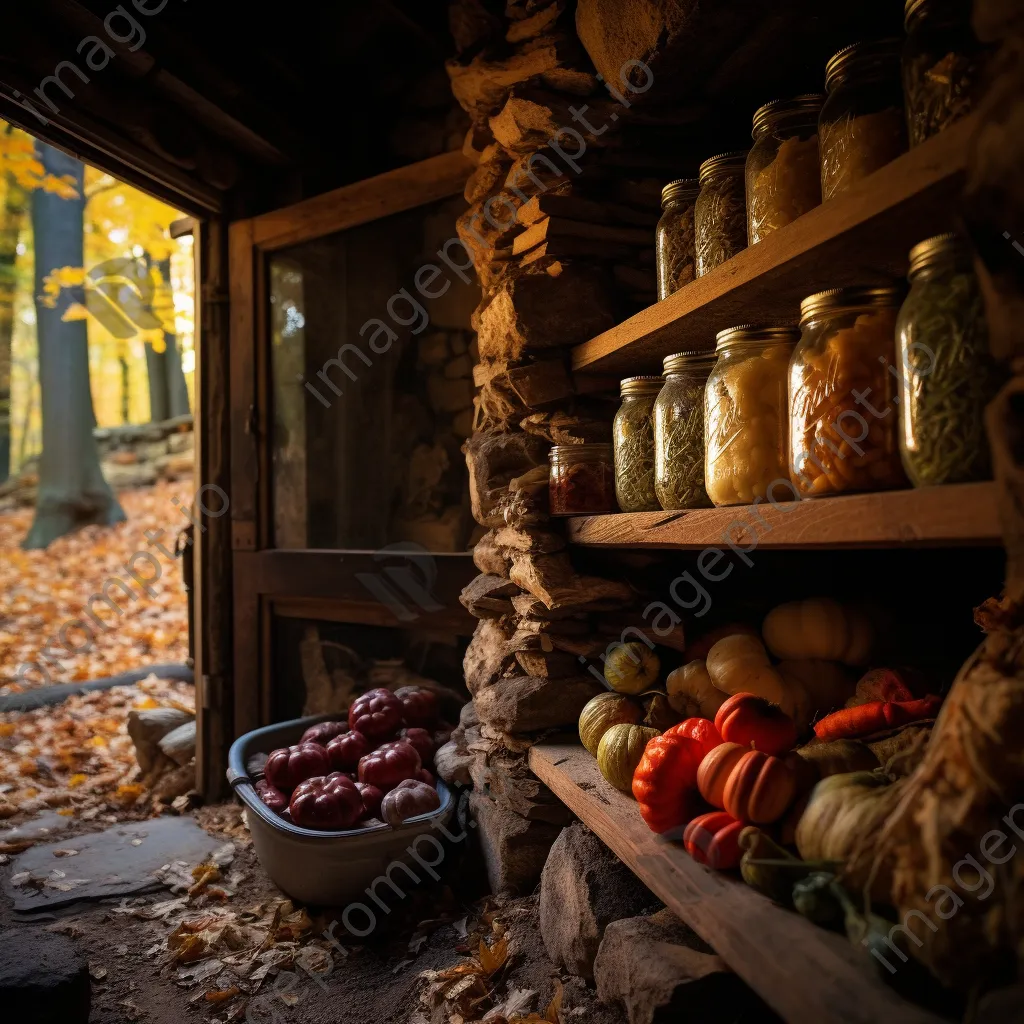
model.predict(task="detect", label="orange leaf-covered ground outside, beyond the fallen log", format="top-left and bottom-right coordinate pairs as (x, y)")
top-left (0, 479), bottom-right (193, 694)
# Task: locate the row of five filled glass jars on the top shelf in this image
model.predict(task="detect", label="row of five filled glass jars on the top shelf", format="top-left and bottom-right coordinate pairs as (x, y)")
top-left (656, 0), bottom-right (985, 299)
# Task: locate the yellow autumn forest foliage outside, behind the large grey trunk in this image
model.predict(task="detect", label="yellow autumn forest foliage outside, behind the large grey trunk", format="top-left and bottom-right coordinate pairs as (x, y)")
top-left (0, 121), bottom-right (196, 484)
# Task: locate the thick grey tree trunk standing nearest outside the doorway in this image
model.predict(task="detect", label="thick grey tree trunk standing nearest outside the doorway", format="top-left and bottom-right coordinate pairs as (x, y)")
top-left (23, 142), bottom-right (125, 548)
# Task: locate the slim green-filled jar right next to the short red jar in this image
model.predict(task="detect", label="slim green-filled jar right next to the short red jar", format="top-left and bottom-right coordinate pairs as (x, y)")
top-left (611, 377), bottom-right (665, 512)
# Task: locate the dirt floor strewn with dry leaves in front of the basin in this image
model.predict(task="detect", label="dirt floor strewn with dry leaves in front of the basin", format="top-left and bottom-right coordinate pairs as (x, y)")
top-left (0, 805), bottom-right (625, 1024)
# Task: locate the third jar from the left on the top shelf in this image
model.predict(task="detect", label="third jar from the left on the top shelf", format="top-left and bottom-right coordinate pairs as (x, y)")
top-left (746, 95), bottom-right (825, 246)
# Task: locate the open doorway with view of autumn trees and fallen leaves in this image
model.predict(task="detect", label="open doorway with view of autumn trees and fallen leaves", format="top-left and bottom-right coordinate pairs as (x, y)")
top-left (0, 121), bottom-right (197, 807)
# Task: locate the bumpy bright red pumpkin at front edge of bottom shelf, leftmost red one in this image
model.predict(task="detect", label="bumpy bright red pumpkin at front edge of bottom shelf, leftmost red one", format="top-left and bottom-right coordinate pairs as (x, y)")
top-left (633, 733), bottom-right (703, 835)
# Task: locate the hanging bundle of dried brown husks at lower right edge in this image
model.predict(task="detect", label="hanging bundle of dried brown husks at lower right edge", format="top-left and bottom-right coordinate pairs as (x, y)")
top-left (848, 628), bottom-right (1024, 988)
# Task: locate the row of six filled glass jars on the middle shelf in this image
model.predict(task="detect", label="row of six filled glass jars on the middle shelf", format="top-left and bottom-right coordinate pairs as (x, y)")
top-left (585, 234), bottom-right (1000, 514)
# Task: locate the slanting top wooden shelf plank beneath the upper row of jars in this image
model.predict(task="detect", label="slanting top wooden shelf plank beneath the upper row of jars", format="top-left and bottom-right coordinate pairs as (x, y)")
top-left (572, 118), bottom-right (975, 377)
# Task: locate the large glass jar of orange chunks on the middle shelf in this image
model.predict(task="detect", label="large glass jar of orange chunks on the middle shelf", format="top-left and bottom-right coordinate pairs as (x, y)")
top-left (790, 286), bottom-right (906, 498)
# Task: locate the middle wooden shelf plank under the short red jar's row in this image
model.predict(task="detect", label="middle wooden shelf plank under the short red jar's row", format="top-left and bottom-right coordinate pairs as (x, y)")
top-left (568, 483), bottom-right (1002, 550)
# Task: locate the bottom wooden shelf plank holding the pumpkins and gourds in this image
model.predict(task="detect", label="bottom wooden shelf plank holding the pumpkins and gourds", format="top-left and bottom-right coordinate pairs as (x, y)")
top-left (529, 743), bottom-right (939, 1024)
